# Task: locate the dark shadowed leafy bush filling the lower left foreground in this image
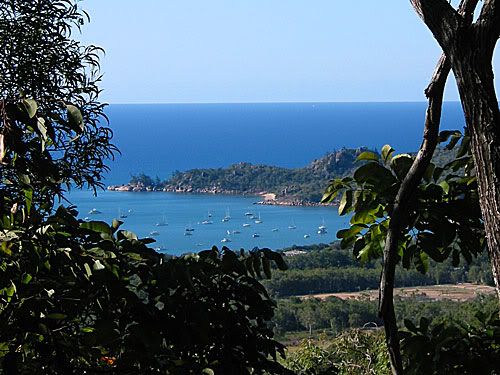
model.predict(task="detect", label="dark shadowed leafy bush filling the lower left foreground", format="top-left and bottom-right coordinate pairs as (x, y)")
top-left (0, 207), bottom-right (292, 374)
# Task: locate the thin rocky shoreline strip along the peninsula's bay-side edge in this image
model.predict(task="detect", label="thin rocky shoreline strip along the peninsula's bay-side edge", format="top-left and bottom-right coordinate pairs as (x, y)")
top-left (106, 184), bottom-right (335, 207)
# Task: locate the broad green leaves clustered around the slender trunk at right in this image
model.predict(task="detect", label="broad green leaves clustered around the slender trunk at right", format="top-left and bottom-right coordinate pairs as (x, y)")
top-left (322, 135), bottom-right (485, 272)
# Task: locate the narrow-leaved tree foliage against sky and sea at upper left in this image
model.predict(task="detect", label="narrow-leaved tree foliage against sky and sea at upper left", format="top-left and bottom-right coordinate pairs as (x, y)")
top-left (0, 0), bottom-right (116, 211)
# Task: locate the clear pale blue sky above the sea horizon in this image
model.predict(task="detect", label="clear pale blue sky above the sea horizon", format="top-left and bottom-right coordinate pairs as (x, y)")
top-left (80, 0), bottom-right (498, 103)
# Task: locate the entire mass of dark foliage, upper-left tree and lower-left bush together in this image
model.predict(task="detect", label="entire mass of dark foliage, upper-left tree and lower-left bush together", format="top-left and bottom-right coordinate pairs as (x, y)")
top-left (0, 0), bottom-right (287, 375)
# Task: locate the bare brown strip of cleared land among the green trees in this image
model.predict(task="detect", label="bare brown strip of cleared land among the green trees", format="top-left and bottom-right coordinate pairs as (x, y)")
top-left (300, 284), bottom-right (495, 302)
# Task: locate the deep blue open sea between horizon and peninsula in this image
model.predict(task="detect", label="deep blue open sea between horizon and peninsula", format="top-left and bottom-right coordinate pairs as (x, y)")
top-left (107, 102), bottom-right (464, 184)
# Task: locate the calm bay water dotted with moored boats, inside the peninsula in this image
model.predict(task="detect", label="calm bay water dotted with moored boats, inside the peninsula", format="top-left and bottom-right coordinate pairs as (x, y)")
top-left (69, 191), bottom-right (348, 255)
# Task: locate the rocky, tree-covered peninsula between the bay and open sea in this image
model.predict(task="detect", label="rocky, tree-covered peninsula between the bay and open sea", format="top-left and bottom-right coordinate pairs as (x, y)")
top-left (108, 147), bottom-right (367, 205)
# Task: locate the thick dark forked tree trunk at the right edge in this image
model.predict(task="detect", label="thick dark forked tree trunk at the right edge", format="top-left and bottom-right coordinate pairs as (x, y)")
top-left (411, 0), bottom-right (500, 302)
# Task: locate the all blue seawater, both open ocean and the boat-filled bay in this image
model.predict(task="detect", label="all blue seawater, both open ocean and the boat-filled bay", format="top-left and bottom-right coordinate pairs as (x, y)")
top-left (69, 102), bottom-right (464, 254)
